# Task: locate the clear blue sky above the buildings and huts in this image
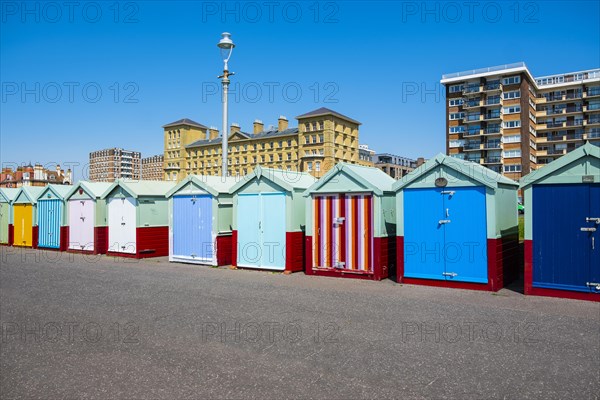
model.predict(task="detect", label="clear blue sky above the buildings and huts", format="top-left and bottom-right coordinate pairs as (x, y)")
top-left (0, 1), bottom-right (600, 179)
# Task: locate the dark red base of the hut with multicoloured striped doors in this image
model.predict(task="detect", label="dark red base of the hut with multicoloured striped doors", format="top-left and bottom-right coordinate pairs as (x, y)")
top-left (304, 236), bottom-right (396, 281)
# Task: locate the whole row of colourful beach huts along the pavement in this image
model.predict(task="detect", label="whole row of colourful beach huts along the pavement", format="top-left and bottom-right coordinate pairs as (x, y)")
top-left (0, 143), bottom-right (600, 301)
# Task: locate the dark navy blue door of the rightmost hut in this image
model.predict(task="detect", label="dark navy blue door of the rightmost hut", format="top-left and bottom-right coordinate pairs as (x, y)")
top-left (532, 184), bottom-right (600, 292)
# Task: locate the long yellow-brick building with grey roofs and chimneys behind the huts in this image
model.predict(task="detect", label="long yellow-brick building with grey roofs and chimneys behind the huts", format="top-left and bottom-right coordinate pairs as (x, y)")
top-left (163, 108), bottom-right (360, 181)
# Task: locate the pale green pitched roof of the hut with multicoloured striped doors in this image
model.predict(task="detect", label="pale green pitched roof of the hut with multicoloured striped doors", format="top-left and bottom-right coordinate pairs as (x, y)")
top-left (304, 163), bottom-right (396, 196)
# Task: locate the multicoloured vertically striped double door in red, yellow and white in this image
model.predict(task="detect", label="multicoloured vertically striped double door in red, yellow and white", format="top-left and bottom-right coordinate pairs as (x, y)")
top-left (313, 195), bottom-right (373, 272)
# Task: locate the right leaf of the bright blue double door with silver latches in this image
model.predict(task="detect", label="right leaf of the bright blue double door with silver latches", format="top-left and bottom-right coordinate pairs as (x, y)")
top-left (442, 186), bottom-right (488, 283)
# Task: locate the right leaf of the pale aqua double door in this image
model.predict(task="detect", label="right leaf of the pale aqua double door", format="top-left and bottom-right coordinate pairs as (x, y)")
top-left (260, 193), bottom-right (285, 270)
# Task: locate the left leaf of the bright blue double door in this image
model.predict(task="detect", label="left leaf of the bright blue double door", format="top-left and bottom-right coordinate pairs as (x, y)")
top-left (404, 188), bottom-right (444, 279)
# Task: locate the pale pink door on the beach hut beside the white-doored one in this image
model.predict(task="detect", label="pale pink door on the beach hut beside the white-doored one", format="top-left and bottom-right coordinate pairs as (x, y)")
top-left (69, 199), bottom-right (95, 251)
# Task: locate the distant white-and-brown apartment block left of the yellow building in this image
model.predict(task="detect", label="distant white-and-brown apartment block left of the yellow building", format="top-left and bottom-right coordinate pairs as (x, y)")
top-left (89, 148), bottom-right (142, 182)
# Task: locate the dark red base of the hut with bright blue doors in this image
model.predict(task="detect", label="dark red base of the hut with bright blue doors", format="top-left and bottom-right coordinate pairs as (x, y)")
top-left (396, 236), bottom-right (520, 292)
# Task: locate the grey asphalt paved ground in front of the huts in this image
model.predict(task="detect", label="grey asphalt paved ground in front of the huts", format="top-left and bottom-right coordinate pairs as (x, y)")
top-left (0, 248), bottom-right (600, 399)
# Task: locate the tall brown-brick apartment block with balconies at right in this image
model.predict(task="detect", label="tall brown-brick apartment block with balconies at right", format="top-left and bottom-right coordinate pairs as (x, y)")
top-left (441, 62), bottom-right (600, 180)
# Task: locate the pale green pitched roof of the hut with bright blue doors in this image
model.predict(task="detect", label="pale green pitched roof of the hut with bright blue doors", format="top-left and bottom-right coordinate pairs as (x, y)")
top-left (394, 153), bottom-right (519, 191)
